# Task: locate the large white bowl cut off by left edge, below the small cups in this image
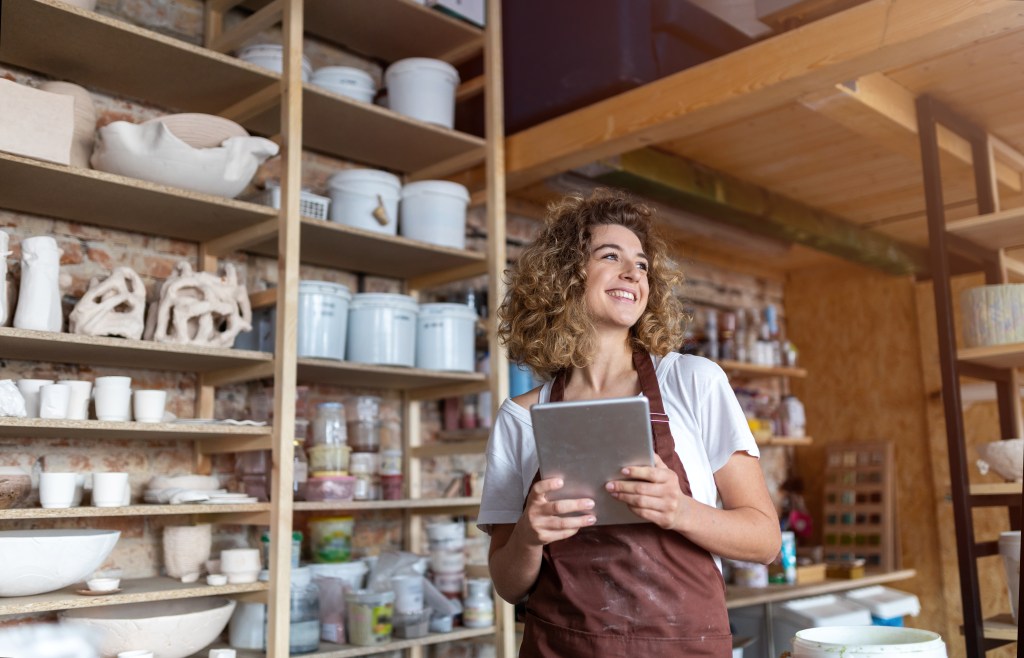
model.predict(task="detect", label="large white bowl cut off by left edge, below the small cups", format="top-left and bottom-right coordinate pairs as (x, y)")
top-left (0, 529), bottom-right (121, 597)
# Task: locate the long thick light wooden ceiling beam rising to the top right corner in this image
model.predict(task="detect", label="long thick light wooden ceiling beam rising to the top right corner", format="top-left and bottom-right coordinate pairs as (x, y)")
top-left (506, 0), bottom-right (1024, 189)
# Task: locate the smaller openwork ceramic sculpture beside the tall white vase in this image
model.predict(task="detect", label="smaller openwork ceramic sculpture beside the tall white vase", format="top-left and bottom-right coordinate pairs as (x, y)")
top-left (68, 267), bottom-right (145, 340)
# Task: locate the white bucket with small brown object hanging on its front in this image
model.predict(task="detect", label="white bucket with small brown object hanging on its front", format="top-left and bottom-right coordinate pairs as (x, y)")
top-left (327, 169), bottom-right (401, 235)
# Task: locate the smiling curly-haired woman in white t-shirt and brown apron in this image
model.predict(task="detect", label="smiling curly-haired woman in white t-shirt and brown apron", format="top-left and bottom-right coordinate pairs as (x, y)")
top-left (478, 191), bottom-right (781, 658)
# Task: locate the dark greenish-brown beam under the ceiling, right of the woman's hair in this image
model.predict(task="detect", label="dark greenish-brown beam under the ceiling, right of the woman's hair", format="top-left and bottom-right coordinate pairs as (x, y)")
top-left (578, 148), bottom-right (928, 275)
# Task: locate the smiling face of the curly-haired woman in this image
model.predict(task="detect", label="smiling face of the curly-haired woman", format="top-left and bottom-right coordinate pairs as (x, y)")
top-left (586, 224), bottom-right (649, 330)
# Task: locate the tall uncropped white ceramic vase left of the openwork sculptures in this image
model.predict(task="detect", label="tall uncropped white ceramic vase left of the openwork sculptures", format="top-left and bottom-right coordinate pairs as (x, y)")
top-left (14, 235), bottom-right (63, 332)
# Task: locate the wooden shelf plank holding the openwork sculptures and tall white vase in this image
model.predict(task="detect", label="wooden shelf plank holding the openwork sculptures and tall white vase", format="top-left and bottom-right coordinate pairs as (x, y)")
top-left (0, 326), bottom-right (272, 372)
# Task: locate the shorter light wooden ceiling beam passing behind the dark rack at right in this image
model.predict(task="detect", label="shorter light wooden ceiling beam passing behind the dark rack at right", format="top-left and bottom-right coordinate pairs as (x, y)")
top-left (800, 73), bottom-right (1021, 192)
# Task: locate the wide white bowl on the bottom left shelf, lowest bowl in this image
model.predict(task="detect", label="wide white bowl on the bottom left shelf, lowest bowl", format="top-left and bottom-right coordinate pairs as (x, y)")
top-left (60, 598), bottom-right (234, 658)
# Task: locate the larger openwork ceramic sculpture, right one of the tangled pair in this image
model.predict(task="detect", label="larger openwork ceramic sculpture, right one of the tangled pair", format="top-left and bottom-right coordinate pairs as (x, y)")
top-left (147, 261), bottom-right (252, 347)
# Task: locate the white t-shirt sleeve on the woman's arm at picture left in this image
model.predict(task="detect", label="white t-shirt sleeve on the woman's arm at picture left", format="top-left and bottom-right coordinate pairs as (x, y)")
top-left (476, 400), bottom-right (536, 534)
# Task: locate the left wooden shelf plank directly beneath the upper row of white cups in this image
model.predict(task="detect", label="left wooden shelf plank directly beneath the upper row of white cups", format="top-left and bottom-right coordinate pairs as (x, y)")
top-left (0, 416), bottom-right (272, 447)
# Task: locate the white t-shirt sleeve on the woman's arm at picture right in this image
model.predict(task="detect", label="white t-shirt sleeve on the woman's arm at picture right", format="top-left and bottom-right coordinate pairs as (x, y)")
top-left (697, 359), bottom-right (761, 473)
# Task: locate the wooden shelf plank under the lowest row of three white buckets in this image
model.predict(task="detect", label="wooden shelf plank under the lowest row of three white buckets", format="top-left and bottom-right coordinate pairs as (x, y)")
top-left (298, 358), bottom-right (486, 391)
